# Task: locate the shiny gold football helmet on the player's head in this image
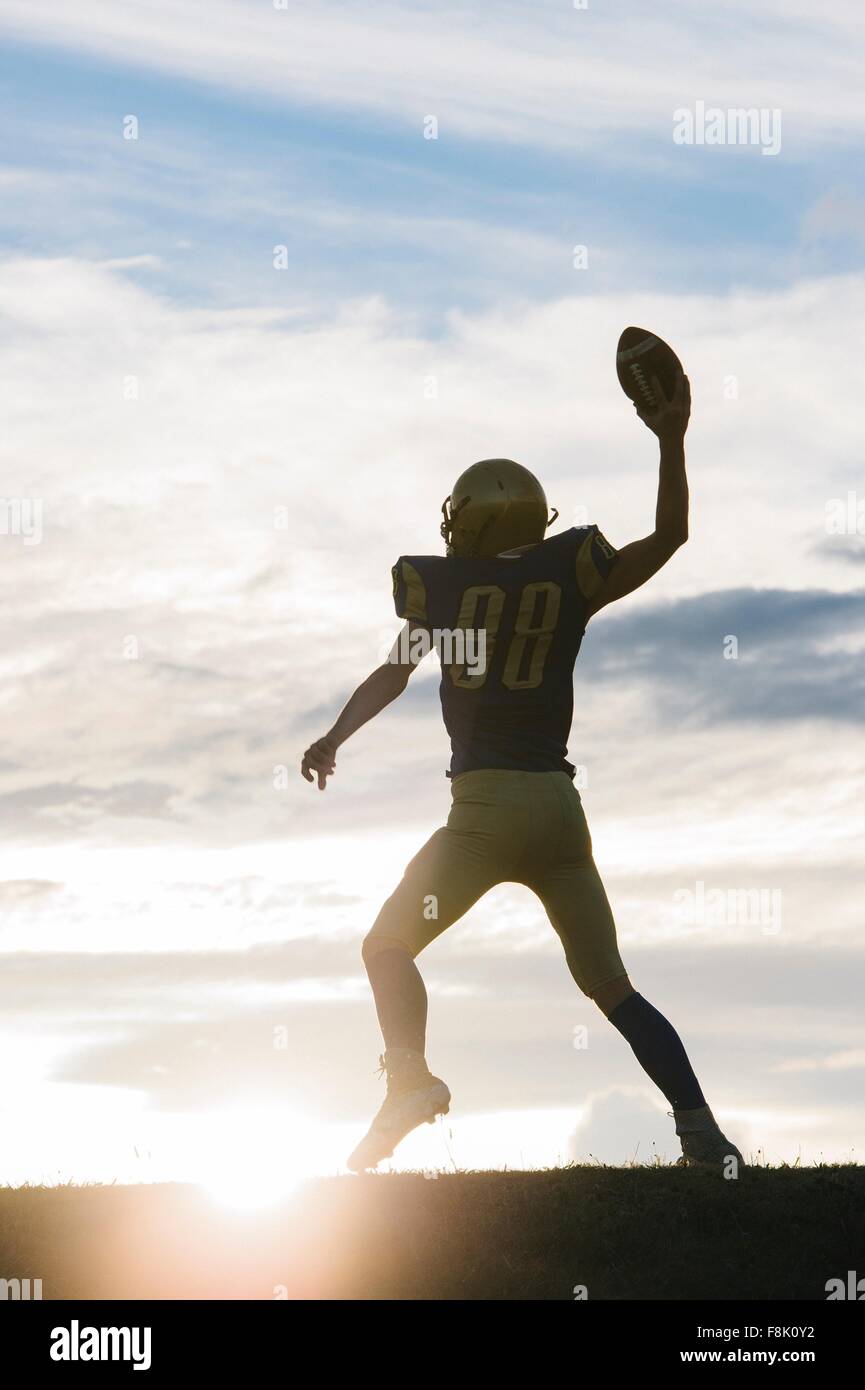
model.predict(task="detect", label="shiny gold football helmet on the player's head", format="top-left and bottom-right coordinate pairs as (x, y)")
top-left (441, 459), bottom-right (559, 557)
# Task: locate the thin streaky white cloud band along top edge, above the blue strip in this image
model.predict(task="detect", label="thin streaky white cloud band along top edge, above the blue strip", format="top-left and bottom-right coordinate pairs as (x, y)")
top-left (3, 0), bottom-right (862, 157)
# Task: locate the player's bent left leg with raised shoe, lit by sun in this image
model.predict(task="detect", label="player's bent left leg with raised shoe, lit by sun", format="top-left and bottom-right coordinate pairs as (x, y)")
top-left (349, 806), bottom-right (501, 1170)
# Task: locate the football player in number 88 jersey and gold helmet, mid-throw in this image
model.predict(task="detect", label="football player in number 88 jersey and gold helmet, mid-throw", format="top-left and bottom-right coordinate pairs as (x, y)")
top-left (302, 373), bottom-right (743, 1173)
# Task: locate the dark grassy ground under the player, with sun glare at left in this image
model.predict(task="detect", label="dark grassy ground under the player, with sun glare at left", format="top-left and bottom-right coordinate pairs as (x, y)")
top-left (0, 1165), bottom-right (865, 1300)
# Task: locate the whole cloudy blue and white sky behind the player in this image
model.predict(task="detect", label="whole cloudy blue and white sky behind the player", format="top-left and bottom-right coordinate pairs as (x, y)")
top-left (0, 0), bottom-right (865, 1195)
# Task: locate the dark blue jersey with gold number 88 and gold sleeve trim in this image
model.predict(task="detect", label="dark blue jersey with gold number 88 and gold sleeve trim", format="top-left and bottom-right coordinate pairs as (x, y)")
top-left (392, 525), bottom-right (616, 777)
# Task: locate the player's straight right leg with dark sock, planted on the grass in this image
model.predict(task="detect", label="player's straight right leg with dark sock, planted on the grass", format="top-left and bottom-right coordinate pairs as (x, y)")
top-left (533, 788), bottom-right (743, 1166)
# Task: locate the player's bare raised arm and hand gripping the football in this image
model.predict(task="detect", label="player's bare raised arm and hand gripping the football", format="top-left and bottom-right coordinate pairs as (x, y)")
top-left (588, 371), bottom-right (691, 616)
